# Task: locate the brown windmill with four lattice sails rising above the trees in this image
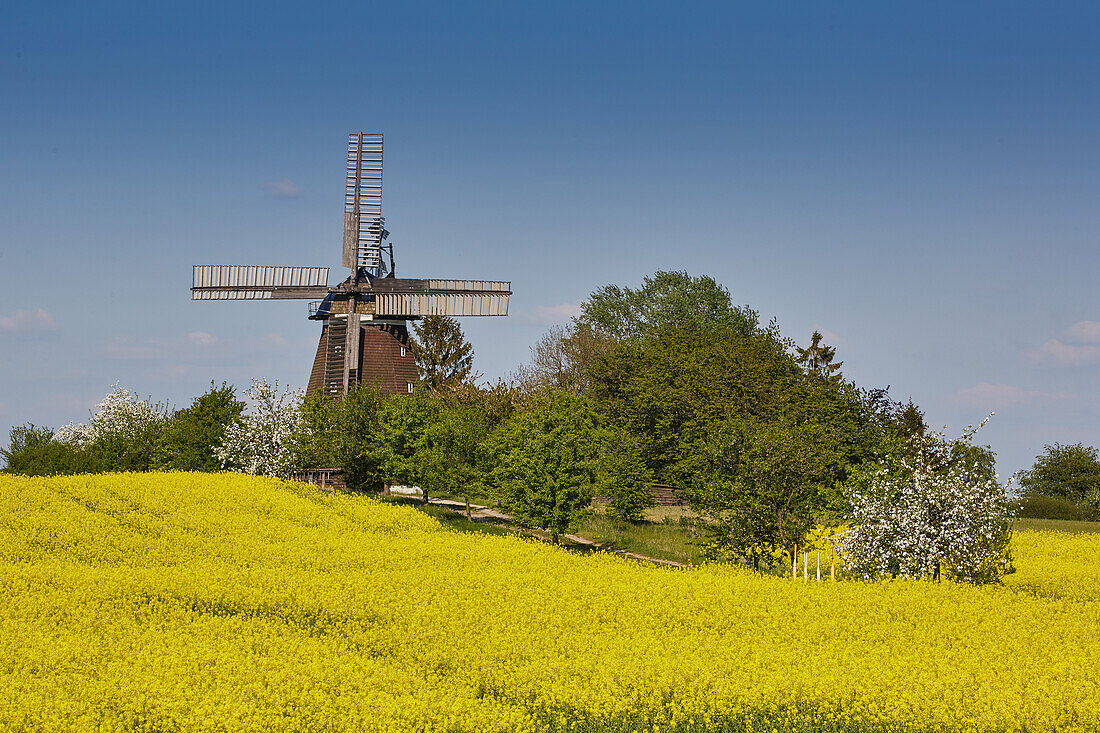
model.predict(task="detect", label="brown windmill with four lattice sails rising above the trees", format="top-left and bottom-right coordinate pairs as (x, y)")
top-left (191, 132), bottom-right (512, 397)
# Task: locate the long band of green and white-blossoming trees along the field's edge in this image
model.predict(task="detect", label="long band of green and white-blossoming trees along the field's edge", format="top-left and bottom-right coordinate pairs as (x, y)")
top-left (6, 272), bottom-right (1064, 580)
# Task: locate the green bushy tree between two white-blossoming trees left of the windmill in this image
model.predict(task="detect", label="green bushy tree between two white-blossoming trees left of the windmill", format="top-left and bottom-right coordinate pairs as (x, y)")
top-left (157, 381), bottom-right (244, 471)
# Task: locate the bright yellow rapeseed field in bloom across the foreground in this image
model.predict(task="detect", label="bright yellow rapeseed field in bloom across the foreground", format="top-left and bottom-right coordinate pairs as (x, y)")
top-left (0, 473), bottom-right (1100, 733)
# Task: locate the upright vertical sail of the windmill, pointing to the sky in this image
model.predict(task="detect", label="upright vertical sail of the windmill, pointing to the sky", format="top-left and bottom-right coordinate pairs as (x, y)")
top-left (342, 132), bottom-right (384, 270)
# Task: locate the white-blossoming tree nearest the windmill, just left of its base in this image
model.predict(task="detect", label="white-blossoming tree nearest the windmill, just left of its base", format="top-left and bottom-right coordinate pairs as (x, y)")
top-left (215, 379), bottom-right (304, 477)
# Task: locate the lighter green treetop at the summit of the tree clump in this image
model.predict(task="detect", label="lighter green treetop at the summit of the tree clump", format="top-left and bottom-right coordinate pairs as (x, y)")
top-left (576, 272), bottom-right (759, 339)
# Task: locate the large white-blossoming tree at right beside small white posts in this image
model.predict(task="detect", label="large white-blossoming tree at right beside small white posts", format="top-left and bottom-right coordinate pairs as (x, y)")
top-left (838, 418), bottom-right (1012, 582)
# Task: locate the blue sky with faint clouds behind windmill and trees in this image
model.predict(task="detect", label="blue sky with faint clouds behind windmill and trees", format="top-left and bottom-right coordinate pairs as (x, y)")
top-left (0, 2), bottom-right (1100, 475)
